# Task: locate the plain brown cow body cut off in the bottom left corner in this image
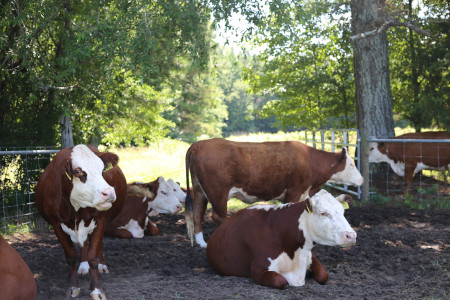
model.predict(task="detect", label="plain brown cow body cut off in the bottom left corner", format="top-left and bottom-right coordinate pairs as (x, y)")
top-left (0, 235), bottom-right (37, 300)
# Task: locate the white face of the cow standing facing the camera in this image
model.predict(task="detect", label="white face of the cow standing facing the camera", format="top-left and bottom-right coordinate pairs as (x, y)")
top-left (70, 145), bottom-right (113, 211)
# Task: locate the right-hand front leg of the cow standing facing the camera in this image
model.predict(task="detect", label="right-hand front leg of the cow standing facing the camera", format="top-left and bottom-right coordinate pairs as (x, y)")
top-left (88, 216), bottom-right (106, 300)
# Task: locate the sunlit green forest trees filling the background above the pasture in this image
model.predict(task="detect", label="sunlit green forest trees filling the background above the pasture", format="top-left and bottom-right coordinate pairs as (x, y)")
top-left (0, 0), bottom-right (450, 147)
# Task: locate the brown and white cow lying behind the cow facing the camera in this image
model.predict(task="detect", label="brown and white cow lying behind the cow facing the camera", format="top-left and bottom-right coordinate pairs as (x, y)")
top-left (78, 177), bottom-right (183, 275)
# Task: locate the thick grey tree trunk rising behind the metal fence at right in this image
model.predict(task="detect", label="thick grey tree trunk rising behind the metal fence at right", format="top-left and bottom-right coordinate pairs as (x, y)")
top-left (351, 0), bottom-right (395, 200)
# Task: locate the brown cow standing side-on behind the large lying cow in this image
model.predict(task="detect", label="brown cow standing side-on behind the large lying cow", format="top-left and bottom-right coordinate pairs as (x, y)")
top-left (185, 139), bottom-right (364, 247)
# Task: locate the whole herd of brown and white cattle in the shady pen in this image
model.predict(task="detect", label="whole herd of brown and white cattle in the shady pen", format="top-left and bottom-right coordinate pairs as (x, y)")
top-left (0, 132), bottom-right (450, 300)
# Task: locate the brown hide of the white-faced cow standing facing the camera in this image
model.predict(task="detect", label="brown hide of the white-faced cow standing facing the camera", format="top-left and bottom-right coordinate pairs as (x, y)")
top-left (36, 147), bottom-right (126, 297)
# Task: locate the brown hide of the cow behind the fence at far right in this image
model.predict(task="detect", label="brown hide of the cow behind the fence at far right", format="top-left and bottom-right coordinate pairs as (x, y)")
top-left (378, 131), bottom-right (450, 194)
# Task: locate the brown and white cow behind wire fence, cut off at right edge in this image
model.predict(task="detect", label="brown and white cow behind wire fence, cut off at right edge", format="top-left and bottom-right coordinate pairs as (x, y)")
top-left (369, 131), bottom-right (450, 195)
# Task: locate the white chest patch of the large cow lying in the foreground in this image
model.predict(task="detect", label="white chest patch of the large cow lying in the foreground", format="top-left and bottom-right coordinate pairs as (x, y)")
top-left (268, 248), bottom-right (312, 286)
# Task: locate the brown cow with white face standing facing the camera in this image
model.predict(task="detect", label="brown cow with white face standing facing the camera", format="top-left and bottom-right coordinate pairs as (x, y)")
top-left (36, 145), bottom-right (127, 299)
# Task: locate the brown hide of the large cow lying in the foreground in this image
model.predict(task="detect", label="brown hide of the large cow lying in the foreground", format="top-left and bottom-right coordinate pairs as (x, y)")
top-left (206, 200), bottom-right (328, 288)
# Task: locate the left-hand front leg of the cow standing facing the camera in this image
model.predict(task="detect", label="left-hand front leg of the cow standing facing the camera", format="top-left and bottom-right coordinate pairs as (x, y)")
top-left (52, 223), bottom-right (80, 298)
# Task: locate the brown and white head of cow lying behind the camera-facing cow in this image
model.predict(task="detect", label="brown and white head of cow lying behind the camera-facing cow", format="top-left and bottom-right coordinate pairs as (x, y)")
top-left (127, 177), bottom-right (183, 214)
